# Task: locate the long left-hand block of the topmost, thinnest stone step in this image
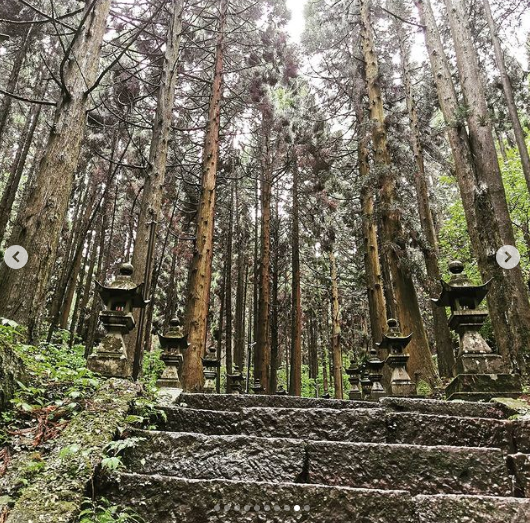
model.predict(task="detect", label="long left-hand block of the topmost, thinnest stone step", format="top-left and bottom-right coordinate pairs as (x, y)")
top-left (174, 393), bottom-right (378, 411)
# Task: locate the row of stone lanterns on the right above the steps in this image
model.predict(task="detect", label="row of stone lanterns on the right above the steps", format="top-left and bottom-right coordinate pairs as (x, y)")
top-left (346, 261), bottom-right (522, 401)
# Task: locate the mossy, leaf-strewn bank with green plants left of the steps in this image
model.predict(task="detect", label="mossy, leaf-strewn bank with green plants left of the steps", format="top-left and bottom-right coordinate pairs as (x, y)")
top-left (0, 327), bottom-right (146, 523)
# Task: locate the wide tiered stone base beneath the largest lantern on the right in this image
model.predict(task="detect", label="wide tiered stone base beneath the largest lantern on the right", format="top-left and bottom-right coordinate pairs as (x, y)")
top-left (445, 374), bottom-right (523, 401)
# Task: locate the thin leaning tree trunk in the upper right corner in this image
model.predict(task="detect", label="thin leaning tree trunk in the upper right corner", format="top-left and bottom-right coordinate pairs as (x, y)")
top-left (483, 0), bottom-right (530, 191)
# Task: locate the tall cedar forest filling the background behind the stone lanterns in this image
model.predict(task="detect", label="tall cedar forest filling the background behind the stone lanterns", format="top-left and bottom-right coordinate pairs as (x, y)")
top-left (0, 0), bottom-right (530, 398)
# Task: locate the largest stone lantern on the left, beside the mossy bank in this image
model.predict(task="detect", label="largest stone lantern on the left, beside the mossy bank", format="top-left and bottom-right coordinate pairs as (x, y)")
top-left (87, 263), bottom-right (146, 378)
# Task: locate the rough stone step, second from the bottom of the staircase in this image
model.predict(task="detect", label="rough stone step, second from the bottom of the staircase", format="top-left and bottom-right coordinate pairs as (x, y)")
top-left (125, 431), bottom-right (514, 496)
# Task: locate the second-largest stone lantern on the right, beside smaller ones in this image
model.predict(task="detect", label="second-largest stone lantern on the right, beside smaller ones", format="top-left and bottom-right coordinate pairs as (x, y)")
top-left (378, 319), bottom-right (416, 396)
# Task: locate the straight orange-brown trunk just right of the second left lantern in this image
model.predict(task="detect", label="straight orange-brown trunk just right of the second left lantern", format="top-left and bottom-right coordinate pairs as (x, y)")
top-left (182, 0), bottom-right (228, 391)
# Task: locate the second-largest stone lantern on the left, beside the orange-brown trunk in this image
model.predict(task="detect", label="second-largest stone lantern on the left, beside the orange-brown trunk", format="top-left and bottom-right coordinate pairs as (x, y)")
top-left (156, 317), bottom-right (189, 389)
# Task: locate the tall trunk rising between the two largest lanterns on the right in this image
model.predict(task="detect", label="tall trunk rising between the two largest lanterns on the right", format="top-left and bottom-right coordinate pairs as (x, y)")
top-left (360, 0), bottom-right (436, 384)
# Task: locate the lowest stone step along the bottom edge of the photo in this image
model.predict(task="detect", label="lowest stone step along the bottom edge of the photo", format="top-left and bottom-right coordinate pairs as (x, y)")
top-left (97, 473), bottom-right (530, 523)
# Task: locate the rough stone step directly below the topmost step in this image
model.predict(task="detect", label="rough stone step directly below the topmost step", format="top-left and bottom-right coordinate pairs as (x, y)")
top-left (160, 407), bottom-right (512, 452)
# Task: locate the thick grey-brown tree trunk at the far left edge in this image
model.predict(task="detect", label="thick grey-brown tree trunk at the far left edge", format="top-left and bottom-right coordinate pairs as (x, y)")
top-left (0, 0), bottom-right (111, 339)
